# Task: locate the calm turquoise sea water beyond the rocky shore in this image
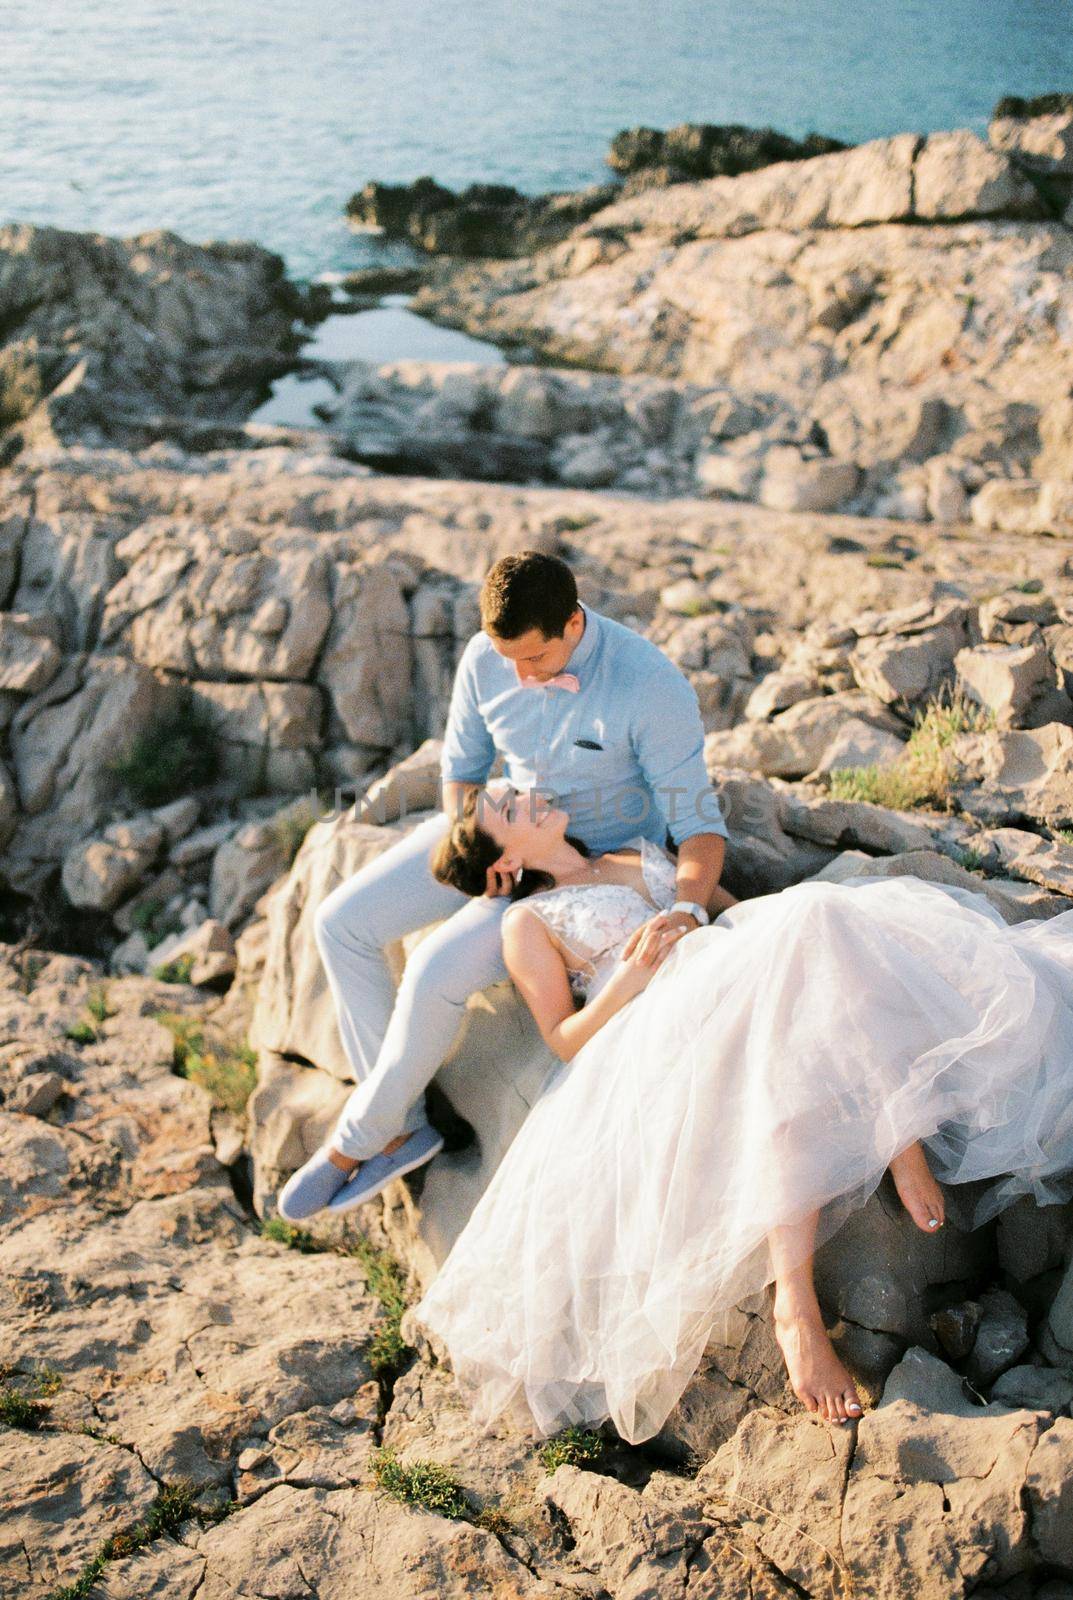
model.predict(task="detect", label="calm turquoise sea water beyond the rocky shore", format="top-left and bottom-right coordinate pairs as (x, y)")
top-left (0, 0), bottom-right (1073, 277)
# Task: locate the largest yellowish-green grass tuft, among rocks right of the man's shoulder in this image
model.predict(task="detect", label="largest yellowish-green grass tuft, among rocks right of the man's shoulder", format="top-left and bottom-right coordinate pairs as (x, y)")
top-left (827, 694), bottom-right (995, 811)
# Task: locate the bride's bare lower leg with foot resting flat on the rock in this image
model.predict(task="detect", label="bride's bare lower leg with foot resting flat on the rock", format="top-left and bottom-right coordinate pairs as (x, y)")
top-left (768, 1213), bottom-right (862, 1422)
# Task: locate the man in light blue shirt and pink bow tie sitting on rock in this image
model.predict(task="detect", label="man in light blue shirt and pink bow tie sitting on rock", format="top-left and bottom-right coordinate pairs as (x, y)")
top-left (278, 550), bottom-right (726, 1221)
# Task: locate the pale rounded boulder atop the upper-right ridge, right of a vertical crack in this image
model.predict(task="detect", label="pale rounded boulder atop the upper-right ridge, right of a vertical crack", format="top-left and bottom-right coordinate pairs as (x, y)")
top-left (913, 128), bottom-right (1047, 221)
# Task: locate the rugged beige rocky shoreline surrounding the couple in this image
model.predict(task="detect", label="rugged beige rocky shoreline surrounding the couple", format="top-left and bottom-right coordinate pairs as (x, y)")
top-left (0, 101), bottom-right (1073, 1600)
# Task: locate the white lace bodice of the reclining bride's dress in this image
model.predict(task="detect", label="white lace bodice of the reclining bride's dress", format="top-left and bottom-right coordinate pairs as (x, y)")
top-left (507, 837), bottom-right (676, 1000)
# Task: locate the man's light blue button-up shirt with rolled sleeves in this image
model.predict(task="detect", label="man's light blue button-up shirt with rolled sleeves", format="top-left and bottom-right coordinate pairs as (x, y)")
top-left (440, 606), bottom-right (728, 851)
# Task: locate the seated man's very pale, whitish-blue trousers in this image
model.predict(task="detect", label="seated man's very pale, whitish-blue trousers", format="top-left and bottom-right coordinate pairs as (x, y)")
top-left (313, 813), bottom-right (510, 1160)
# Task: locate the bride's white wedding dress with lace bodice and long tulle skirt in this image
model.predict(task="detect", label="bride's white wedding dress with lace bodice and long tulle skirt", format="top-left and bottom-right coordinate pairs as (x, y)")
top-left (416, 840), bottom-right (1073, 1442)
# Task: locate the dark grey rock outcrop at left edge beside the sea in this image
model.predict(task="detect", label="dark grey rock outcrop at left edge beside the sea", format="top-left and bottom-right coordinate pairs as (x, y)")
top-left (0, 222), bottom-right (305, 445)
